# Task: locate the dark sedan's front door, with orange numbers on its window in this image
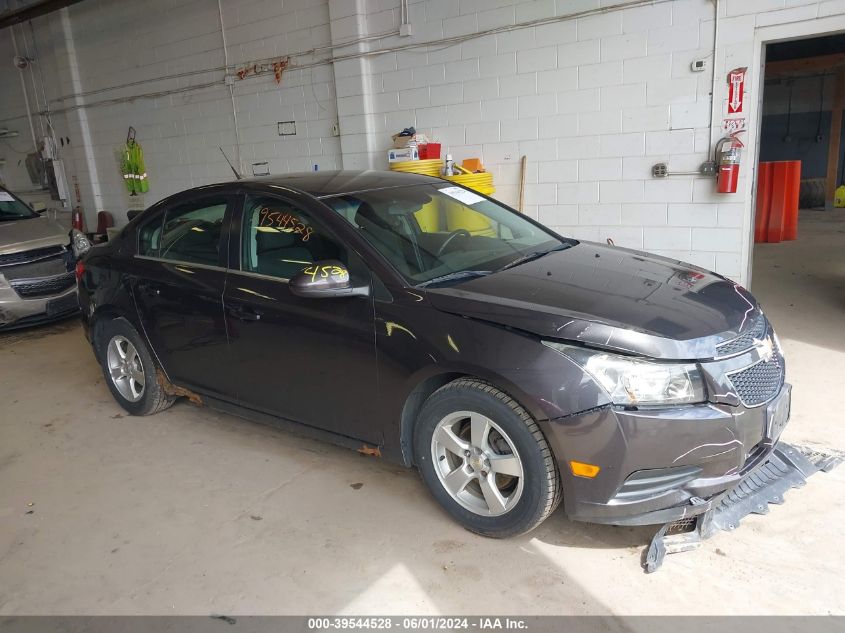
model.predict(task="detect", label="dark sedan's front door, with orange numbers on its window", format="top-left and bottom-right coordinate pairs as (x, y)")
top-left (224, 194), bottom-right (381, 444)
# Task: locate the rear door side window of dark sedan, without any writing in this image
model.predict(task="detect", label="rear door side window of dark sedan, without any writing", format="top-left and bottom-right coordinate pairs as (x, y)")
top-left (155, 197), bottom-right (227, 266)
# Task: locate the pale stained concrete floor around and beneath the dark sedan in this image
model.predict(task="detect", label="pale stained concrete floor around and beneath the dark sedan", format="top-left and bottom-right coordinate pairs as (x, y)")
top-left (0, 213), bottom-right (845, 614)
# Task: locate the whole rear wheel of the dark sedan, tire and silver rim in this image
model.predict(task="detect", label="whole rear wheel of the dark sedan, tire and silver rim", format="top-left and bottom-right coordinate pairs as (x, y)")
top-left (97, 318), bottom-right (174, 415)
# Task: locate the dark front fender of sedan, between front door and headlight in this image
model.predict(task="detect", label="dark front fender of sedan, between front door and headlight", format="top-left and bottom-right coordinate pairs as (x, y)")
top-left (376, 301), bottom-right (607, 465)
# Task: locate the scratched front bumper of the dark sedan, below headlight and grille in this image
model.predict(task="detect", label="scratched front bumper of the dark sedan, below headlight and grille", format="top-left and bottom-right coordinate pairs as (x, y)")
top-left (546, 384), bottom-right (791, 525)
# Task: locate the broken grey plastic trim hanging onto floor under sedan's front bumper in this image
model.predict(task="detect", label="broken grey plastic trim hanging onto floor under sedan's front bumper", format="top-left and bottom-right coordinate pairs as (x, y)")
top-left (643, 442), bottom-right (843, 573)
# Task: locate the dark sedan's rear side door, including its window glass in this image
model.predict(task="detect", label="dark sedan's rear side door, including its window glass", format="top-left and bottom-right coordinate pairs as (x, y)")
top-left (131, 194), bottom-right (236, 396)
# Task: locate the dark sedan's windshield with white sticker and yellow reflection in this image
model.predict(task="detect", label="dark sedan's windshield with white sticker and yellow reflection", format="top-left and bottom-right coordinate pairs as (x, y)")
top-left (323, 182), bottom-right (573, 285)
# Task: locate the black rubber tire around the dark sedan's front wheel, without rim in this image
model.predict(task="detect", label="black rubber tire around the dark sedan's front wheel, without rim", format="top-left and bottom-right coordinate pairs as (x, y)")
top-left (414, 378), bottom-right (562, 538)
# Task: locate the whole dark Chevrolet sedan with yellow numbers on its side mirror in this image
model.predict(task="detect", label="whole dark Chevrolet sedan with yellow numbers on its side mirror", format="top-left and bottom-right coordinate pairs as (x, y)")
top-left (78, 172), bottom-right (790, 536)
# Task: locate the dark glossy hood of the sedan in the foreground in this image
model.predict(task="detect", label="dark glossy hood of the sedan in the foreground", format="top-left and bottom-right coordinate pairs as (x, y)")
top-left (426, 242), bottom-right (760, 359)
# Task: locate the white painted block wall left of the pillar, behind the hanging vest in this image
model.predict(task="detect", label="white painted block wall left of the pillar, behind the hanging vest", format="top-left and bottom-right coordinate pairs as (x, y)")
top-left (0, 0), bottom-right (340, 217)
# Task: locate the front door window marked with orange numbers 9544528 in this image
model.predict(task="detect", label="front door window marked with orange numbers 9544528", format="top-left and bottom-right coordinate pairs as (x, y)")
top-left (241, 196), bottom-right (349, 279)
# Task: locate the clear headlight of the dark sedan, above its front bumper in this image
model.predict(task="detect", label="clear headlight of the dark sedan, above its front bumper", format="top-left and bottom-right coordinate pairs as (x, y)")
top-left (543, 341), bottom-right (706, 406)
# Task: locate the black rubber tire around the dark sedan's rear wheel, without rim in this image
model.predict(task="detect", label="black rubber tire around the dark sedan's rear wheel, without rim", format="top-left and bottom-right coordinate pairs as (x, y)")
top-left (97, 318), bottom-right (175, 415)
